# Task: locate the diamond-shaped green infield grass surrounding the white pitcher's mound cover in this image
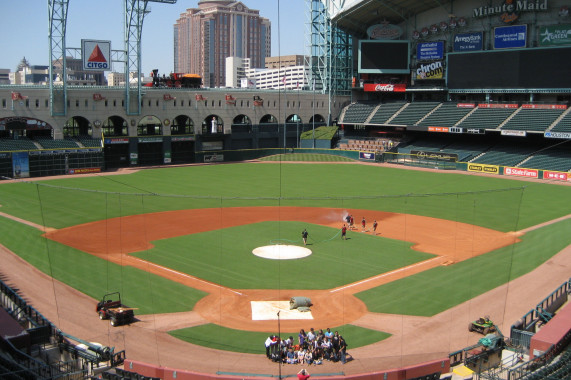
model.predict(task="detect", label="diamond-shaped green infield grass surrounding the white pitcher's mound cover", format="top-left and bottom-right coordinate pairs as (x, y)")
top-left (134, 222), bottom-right (434, 289)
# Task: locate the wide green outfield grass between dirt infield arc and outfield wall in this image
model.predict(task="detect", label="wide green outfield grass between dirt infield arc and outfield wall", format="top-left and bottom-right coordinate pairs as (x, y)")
top-left (0, 163), bottom-right (571, 231)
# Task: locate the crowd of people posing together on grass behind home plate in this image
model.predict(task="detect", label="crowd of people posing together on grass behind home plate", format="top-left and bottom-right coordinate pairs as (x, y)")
top-left (265, 327), bottom-right (350, 365)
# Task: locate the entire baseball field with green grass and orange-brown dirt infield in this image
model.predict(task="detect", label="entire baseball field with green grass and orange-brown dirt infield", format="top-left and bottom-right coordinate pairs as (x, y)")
top-left (0, 157), bottom-right (571, 373)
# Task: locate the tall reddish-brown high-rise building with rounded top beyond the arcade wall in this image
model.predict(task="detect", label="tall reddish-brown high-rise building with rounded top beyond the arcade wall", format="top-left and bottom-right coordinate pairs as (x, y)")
top-left (174, 0), bottom-right (271, 87)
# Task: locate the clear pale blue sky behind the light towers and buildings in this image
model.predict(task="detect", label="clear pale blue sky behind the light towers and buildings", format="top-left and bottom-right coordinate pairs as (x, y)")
top-left (0, 0), bottom-right (307, 75)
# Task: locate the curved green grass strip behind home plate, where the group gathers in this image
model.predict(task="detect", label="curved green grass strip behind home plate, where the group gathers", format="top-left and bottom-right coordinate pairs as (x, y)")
top-left (169, 324), bottom-right (391, 354)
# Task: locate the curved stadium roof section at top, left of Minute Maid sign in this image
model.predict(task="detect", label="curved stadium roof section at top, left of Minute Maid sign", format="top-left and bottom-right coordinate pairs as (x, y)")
top-left (332, 0), bottom-right (453, 37)
